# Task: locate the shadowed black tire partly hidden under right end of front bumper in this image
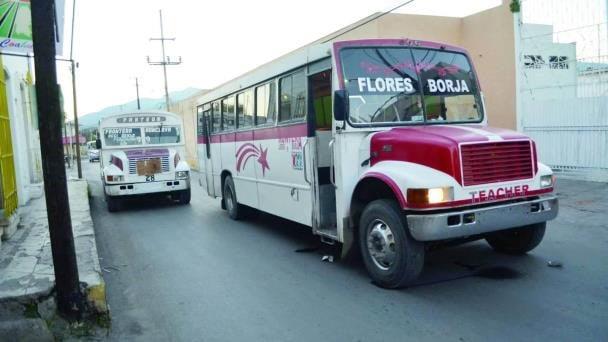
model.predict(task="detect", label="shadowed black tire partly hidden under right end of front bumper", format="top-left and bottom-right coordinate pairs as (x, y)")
top-left (486, 222), bottom-right (547, 255)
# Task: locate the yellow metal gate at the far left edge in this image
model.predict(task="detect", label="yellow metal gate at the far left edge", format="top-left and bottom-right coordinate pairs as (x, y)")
top-left (0, 60), bottom-right (18, 218)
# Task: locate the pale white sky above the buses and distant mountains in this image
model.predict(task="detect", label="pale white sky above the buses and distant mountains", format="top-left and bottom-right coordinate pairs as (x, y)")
top-left (59, 0), bottom-right (501, 116)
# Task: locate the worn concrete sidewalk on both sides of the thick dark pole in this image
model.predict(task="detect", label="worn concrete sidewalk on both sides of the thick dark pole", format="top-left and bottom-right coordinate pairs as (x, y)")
top-left (0, 179), bottom-right (107, 321)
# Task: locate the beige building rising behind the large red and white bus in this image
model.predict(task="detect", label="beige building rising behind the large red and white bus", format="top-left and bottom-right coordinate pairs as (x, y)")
top-left (172, 0), bottom-right (517, 168)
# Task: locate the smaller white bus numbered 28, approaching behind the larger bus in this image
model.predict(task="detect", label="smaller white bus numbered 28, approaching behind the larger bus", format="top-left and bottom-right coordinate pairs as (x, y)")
top-left (98, 111), bottom-right (190, 212)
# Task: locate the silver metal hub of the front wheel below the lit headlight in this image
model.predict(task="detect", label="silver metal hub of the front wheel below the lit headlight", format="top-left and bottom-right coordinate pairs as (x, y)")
top-left (367, 220), bottom-right (396, 270)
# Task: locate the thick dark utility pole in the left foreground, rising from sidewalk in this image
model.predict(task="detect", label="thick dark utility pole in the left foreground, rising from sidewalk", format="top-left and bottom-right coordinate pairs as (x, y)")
top-left (31, 0), bottom-right (84, 319)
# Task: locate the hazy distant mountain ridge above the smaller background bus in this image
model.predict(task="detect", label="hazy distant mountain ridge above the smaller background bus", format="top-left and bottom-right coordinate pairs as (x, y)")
top-left (78, 88), bottom-right (200, 129)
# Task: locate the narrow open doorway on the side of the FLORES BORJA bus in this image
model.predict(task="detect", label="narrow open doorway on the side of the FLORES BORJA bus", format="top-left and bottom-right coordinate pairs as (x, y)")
top-left (308, 59), bottom-right (337, 239)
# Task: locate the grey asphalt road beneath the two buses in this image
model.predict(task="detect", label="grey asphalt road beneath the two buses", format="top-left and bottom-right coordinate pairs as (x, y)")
top-left (84, 163), bottom-right (608, 341)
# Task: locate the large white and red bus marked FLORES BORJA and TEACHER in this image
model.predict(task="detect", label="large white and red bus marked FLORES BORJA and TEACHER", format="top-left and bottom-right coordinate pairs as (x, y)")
top-left (198, 39), bottom-right (558, 288)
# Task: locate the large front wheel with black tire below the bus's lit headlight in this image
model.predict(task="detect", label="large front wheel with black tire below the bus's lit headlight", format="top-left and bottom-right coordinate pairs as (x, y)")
top-left (359, 199), bottom-right (425, 289)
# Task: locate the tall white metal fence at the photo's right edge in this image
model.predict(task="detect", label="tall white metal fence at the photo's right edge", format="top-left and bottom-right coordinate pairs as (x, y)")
top-left (517, 0), bottom-right (608, 181)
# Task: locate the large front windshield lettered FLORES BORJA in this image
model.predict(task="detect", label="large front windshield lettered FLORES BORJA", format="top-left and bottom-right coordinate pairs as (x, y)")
top-left (340, 47), bottom-right (483, 126)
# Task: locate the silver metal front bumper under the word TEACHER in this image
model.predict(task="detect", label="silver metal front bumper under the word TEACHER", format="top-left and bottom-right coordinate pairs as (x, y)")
top-left (407, 196), bottom-right (559, 241)
